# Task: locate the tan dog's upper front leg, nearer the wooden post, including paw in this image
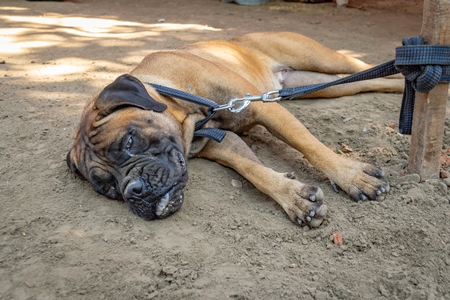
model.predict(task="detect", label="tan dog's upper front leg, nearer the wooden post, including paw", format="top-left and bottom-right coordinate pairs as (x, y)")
top-left (252, 103), bottom-right (389, 201)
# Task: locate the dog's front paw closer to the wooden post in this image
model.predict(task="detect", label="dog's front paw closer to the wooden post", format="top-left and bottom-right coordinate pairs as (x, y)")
top-left (330, 159), bottom-right (390, 201)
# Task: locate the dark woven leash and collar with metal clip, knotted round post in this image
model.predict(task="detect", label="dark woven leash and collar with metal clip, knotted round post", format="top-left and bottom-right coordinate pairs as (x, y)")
top-left (147, 36), bottom-right (450, 142)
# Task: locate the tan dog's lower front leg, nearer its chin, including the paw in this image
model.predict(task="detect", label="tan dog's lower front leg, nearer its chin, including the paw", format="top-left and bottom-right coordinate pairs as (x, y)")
top-left (198, 132), bottom-right (327, 227)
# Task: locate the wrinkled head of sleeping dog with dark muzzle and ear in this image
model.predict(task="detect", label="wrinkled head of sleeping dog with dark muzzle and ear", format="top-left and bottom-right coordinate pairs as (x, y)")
top-left (67, 75), bottom-right (187, 220)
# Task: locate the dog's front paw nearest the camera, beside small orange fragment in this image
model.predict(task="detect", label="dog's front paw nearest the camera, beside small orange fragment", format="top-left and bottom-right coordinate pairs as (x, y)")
top-left (274, 173), bottom-right (327, 227)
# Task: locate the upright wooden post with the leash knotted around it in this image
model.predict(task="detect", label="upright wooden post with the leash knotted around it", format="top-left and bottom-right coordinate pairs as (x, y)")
top-left (408, 0), bottom-right (450, 181)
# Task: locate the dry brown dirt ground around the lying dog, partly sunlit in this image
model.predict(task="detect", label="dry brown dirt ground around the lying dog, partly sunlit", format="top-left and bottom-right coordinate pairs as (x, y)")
top-left (0, 0), bottom-right (450, 300)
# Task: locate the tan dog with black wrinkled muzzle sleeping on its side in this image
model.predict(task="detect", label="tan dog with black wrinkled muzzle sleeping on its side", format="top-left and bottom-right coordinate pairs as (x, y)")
top-left (67, 32), bottom-right (403, 227)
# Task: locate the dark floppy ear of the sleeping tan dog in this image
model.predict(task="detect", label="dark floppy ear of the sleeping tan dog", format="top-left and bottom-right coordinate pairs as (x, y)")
top-left (94, 74), bottom-right (167, 117)
